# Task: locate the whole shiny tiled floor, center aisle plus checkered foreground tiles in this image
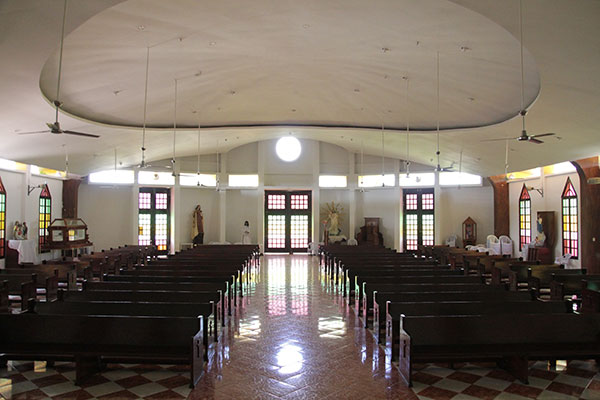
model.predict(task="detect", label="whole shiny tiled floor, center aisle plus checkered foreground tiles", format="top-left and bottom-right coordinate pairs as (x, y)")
top-left (0, 255), bottom-right (600, 399)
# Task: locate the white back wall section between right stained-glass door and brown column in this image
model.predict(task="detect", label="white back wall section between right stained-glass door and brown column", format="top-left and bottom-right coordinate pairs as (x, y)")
top-left (435, 184), bottom-right (494, 246)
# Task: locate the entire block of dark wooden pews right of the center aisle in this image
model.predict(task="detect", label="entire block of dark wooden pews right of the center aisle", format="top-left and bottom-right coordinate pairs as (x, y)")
top-left (321, 246), bottom-right (600, 385)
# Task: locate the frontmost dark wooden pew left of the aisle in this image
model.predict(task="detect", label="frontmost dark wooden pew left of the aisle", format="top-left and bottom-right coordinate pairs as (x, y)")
top-left (0, 314), bottom-right (204, 387)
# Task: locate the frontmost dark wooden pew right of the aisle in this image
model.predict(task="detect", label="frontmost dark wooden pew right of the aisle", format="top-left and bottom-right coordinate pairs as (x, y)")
top-left (398, 313), bottom-right (600, 385)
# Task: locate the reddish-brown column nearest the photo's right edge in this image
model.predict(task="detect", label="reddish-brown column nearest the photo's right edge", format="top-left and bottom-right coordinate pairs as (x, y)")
top-left (571, 157), bottom-right (600, 274)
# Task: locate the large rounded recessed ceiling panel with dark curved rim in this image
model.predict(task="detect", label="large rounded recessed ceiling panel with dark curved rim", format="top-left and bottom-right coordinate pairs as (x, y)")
top-left (40, 0), bottom-right (540, 130)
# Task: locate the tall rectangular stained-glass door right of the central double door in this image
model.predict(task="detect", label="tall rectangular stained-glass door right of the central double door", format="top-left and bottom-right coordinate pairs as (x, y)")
top-left (403, 189), bottom-right (435, 250)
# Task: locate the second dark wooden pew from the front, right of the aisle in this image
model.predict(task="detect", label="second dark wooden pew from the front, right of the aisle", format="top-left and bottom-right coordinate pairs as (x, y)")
top-left (382, 297), bottom-right (571, 359)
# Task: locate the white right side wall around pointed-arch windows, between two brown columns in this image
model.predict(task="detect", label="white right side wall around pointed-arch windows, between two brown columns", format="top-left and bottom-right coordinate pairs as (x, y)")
top-left (508, 173), bottom-right (581, 268)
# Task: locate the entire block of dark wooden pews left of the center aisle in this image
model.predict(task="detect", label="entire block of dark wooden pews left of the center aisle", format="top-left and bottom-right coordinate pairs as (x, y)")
top-left (0, 245), bottom-right (259, 387)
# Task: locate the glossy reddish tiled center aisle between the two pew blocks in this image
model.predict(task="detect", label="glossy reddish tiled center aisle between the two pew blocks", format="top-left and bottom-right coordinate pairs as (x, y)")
top-left (189, 255), bottom-right (417, 399)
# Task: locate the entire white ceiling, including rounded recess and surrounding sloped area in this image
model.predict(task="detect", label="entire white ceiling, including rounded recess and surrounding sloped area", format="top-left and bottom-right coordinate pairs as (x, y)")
top-left (0, 0), bottom-right (600, 175)
